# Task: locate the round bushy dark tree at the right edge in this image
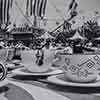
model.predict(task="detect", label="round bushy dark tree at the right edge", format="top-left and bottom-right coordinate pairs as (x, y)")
top-left (78, 20), bottom-right (100, 40)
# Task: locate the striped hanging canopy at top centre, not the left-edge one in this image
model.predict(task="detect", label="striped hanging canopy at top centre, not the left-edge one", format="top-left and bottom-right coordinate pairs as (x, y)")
top-left (26, 0), bottom-right (47, 17)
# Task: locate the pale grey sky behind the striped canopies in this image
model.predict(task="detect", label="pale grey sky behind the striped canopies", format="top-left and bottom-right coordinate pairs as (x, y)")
top-left (11, 0), bottom-right (100, 30)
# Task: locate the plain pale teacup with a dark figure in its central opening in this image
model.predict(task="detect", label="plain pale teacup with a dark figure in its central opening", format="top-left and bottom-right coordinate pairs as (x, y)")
top-left (21, 50), bottom-right (54, 72)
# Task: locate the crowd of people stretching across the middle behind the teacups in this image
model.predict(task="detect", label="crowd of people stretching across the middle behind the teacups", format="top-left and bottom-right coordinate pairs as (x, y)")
top-left (0, 35), bottom-right (100, 65)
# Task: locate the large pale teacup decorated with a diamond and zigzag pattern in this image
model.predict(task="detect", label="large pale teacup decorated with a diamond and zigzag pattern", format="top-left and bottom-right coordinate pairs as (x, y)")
top-left (54, 54), bottom-right (100, 82)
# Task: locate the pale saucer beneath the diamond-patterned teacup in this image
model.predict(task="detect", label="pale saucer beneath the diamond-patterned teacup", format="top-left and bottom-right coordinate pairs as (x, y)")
top-left (47, 74), bottom-right (100, 87)
